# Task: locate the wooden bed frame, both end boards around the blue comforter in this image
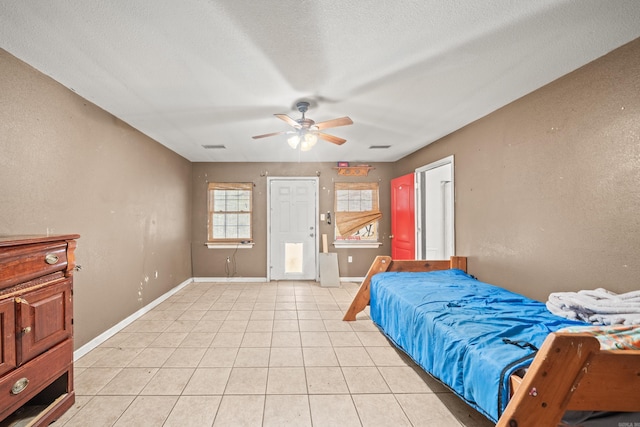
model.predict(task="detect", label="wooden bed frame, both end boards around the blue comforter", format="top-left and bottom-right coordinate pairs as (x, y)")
top-left (343, 256), bottom-right (640, 427)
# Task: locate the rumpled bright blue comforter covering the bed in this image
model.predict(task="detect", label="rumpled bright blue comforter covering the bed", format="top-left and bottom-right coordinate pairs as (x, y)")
top-left (370, 270), bottom-right (584, 422)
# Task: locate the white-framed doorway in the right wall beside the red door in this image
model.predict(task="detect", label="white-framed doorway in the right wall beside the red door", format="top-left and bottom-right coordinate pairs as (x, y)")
top-left (416, 156), bottom-right (455, 260)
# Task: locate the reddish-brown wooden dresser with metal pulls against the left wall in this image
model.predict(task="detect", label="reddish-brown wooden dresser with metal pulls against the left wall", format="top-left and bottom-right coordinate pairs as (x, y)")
top-left (0, 234), bottom-right (80, 426)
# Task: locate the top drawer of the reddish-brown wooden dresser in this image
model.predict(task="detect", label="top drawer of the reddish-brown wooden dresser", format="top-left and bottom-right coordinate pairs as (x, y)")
top-left (0, 242), bottom-right (67, 289)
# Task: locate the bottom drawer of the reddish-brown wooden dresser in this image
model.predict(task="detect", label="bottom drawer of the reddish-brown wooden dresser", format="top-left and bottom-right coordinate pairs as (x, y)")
top-left (0, 339), bottom-right (73, 420)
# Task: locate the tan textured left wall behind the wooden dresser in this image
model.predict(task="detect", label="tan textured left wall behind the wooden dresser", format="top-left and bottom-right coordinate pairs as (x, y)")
top-left (0, 50), bottom-right (191, 348)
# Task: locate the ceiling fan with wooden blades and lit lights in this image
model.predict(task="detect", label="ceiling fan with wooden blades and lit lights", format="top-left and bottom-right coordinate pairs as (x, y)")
top-left (252, 101), bottom-right (353, 151)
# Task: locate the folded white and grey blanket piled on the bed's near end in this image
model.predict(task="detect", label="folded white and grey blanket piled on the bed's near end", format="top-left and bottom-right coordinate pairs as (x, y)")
top-left (546, 288), bottom-right (640, 325)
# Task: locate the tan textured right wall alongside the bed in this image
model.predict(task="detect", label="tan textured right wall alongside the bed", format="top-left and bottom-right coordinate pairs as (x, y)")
top-left (396, 39), bottom-right (640, 300)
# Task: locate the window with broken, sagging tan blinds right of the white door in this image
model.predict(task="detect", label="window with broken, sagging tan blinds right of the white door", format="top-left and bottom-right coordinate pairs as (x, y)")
top-left (334, 182), bottom-right (382, 247)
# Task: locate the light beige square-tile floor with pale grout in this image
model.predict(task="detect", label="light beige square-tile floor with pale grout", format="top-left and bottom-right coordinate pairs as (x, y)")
top-left (54, 282), bottom-right (493, 427)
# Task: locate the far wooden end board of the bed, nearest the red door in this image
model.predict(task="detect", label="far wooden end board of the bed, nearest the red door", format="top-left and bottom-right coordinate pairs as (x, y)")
top-left (342, 256), bottom-right (467, 321)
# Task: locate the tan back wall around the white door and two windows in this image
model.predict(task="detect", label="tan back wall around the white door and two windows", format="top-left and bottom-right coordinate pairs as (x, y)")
top-left (192, 163), bottom-right (393, 278)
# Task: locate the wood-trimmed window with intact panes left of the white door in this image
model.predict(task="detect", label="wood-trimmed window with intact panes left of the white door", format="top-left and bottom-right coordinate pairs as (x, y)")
top-left (207, 182), bottom-right (253, 243)
